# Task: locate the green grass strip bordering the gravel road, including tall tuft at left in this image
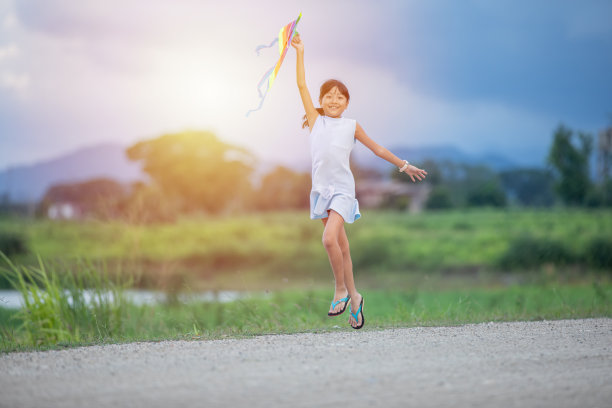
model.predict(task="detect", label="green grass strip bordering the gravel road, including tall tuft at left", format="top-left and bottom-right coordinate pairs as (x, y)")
top-left (0, 252), bottom-right (612, 352)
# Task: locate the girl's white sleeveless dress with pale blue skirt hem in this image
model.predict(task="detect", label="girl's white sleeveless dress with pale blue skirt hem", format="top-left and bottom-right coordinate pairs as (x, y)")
top-left (310, 115), bottom-right (361, 224)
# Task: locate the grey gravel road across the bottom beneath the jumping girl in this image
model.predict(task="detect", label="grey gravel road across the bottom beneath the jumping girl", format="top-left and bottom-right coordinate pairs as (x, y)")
top-left (0, 318), bottom-right (612, 408)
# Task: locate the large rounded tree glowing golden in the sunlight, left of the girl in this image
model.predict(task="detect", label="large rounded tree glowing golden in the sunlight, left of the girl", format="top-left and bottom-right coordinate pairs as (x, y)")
top-left (126, 131), bottom-right (254, 213)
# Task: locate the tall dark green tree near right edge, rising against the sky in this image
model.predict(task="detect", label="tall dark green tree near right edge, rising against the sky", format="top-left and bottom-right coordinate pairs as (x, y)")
top-left (548, 124), bottom-right (593, 205)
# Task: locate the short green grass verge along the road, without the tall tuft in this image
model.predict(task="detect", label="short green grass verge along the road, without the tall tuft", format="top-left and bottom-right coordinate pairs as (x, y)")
top-left (0, 282), bottom-right (612, 351)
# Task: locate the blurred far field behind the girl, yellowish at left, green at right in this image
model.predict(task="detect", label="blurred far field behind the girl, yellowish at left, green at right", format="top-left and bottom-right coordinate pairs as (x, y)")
top-left (0, 209), bottom-right (612, 288)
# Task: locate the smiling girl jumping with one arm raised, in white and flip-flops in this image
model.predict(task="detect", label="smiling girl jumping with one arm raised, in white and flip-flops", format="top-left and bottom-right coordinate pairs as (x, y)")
top-left (291, 34), bottom-right (427, 329)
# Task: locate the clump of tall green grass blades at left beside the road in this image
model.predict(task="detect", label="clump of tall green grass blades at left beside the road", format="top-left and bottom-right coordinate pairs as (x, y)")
top-left (0, 252), bottom-right (131, 346)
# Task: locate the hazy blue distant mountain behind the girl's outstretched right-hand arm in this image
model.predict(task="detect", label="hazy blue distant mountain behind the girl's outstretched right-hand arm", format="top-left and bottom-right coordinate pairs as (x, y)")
top-left (354, 145), bottom-right (520, 172)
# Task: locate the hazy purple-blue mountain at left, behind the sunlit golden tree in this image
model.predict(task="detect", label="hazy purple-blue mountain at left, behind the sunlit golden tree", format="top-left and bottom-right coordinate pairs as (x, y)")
top-left (0, 143), bottom-right (148, 203)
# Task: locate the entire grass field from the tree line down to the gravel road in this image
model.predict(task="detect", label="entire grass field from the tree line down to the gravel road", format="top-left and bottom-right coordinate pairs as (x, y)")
top-left (0, 209), bottom-right (612, 351)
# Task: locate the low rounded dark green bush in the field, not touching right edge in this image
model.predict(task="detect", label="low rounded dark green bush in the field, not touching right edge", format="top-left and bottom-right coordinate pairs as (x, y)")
top-left (498, 236), bottom-right (575, 269)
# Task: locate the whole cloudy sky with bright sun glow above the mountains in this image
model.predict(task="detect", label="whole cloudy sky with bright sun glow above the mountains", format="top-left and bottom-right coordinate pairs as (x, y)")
top-left (0, 0), bottom-right (612, 171)
